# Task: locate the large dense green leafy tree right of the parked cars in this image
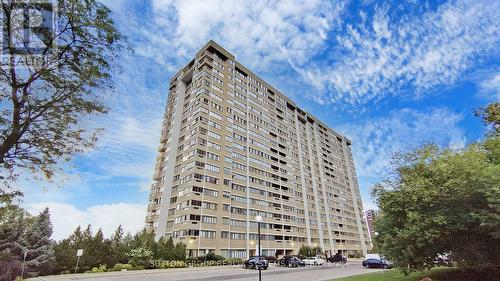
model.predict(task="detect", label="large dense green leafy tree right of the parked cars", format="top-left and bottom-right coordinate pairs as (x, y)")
top-left (373, 134), bottom-right (500, 271)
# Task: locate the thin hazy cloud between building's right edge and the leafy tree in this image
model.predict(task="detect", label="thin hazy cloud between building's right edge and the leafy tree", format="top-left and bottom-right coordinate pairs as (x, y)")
top-left (339, 108), bottom-right (466, 178)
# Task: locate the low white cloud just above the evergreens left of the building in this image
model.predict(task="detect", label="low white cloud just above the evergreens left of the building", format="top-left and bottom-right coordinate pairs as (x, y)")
top-left (27, 202), bottom-right (146, 240)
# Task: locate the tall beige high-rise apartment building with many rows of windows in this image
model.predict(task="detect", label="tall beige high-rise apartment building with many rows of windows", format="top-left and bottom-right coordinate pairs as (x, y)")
top-left (146, 41), bottom-right (369, 258)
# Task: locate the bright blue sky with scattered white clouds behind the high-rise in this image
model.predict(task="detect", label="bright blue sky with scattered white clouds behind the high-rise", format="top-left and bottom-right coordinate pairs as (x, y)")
top-left (20, 0), bottom-right (500, 239)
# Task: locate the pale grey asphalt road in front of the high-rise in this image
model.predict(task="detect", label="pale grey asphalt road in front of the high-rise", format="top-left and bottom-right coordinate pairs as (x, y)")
top-left (30, 263), bottom-right (380, 281)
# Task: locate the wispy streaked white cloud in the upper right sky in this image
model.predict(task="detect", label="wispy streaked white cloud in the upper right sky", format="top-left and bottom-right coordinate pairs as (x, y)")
top-left (296, 0), bottom-right (500, 104)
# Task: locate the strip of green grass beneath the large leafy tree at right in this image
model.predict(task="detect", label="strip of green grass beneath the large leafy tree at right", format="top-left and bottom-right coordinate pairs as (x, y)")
top-left (334, 267), bottom-right (499, 281)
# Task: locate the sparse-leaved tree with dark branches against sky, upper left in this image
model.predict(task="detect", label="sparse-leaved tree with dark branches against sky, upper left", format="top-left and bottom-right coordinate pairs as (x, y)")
top-left (0, 0), bottom-right (125, 182)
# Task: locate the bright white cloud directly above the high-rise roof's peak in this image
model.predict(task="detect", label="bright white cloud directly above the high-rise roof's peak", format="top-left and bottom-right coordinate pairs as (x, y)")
top-left (124, 0), bottom-right (346, 71)
